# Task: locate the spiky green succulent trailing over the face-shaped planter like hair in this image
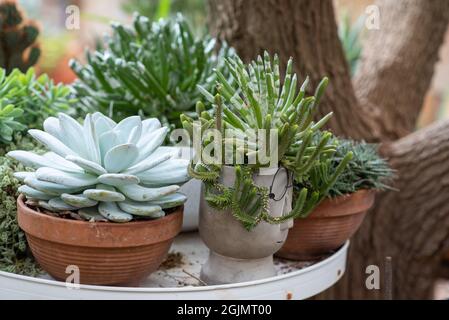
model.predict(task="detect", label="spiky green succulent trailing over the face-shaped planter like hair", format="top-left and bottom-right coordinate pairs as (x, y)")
top-left (181, 53), bottom-right (351, 229)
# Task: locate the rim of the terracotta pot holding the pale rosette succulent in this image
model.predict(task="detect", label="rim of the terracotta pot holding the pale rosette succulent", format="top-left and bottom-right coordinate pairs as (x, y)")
top-left (17, 194), bottom-right (184, 248)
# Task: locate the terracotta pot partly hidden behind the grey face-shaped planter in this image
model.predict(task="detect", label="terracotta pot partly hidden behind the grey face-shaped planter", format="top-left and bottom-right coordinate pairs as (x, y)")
top-left (276, 190), bottom-right (375, 261)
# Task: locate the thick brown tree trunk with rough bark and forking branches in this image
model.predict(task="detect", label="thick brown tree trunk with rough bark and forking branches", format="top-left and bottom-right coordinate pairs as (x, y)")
top-left (209, 0), bottom-right (449, 299)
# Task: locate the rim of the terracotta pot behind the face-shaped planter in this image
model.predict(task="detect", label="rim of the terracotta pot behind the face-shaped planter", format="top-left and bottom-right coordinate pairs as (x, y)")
top-left (306, 189), bottom-right (377, 219)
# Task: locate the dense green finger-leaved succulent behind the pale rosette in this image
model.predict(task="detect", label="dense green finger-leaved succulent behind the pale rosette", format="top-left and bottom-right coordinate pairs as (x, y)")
top-left (70, 14), bottom-right (233, 127)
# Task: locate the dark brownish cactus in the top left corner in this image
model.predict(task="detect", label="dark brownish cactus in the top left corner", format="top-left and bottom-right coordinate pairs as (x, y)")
top-left (0, 0), bottom-right (41, 74)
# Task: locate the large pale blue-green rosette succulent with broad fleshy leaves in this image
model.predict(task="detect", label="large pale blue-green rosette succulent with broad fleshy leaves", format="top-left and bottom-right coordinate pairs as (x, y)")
top-left (8, 113), bottom-right (189, 222)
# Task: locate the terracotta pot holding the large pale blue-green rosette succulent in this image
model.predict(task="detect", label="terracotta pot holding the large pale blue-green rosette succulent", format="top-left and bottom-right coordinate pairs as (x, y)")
top-left (17, 195), bottom-right (183, 285)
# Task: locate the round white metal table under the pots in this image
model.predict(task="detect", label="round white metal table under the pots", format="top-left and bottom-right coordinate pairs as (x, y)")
top-left (0, 232), bottom-right (349, 300)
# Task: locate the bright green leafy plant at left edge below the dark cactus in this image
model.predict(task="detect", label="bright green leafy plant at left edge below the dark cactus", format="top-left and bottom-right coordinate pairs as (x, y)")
top-left (0, 68), bottom-right (76, 143)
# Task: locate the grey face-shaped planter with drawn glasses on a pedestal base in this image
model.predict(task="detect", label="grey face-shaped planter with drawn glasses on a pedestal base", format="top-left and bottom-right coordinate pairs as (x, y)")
top-left (199, 166), bottom-right (292, 284)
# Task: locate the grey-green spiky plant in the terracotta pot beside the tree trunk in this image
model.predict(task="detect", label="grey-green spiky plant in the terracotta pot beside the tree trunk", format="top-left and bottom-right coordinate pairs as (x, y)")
top-left (296, 137), bottom-right (394, 198)
